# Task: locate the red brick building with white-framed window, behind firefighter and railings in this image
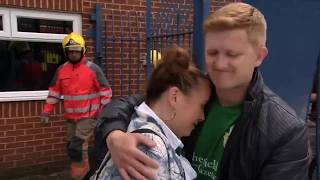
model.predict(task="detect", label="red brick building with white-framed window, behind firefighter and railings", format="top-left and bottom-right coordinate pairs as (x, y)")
top-left (0, 0), bottom-right (222, 179)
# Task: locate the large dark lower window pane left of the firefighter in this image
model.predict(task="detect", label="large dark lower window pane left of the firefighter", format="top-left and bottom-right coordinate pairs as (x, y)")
top-left (0, 41), bottom-right (66, 92)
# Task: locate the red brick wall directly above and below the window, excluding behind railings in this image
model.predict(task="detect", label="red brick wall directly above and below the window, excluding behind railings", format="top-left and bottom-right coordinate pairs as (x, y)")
top-left (0, 0), bottom-right (82, 179)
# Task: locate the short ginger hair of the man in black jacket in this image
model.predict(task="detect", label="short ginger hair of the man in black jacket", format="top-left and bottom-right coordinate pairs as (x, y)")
top-left (203, 2), bottom-right (267, 46)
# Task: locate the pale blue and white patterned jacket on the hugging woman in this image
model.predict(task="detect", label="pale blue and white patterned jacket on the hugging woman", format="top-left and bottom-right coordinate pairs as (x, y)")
top-left (90, 103), bottom-right (196, 180)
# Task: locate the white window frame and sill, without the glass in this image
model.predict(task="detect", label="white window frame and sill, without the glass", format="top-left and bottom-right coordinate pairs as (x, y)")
top-left (0, 7), bottom-right (82, 102)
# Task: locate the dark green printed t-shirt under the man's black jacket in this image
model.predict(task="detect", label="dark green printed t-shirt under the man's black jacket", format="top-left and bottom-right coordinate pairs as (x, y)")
top-left (192, 101), bottom-right (243, 180)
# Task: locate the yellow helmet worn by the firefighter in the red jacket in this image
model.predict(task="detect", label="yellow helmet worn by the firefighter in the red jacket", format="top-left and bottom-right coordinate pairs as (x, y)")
top-left (62, 32), bottom-right (86, 55)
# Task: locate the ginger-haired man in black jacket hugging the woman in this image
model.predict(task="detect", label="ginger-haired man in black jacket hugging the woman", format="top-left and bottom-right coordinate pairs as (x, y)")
top-left (92, 3), bottom-right (309, 180)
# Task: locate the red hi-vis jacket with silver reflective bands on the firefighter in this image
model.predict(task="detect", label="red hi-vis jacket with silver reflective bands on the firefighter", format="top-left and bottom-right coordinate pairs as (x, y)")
top-left (43, 57), bottom-right (112, 122)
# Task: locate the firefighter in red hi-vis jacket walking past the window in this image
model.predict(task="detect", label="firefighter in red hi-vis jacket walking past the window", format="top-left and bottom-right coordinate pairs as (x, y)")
top-left (41, 33), bottom-right (112, 179)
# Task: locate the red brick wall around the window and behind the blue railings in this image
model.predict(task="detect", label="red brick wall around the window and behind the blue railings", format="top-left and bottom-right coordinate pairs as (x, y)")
top-left (0, 0), bottom-right (235, 179)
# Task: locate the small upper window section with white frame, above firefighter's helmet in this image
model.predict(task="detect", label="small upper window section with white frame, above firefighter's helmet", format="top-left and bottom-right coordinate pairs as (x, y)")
top-left (10, 10), bottom-right (82, 41)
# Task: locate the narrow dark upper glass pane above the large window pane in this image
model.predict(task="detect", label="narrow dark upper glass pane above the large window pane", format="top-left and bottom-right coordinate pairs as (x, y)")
top-left (17, 18), bottom-right (73, 34)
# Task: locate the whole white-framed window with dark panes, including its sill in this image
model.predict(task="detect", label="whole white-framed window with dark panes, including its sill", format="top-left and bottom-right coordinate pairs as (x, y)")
top-left (0, 8), bottom-right (82, 102)
